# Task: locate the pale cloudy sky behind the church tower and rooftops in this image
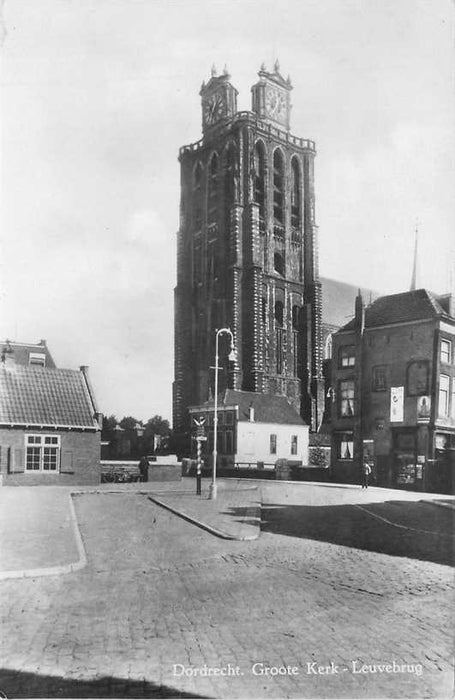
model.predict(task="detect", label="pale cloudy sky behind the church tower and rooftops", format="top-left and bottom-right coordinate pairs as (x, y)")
top-left (0, 0), bottom-right (455, 420)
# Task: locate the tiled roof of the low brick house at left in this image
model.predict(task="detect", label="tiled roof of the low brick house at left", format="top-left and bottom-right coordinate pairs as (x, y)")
top-left (0, 363), bottom-right (98, 428)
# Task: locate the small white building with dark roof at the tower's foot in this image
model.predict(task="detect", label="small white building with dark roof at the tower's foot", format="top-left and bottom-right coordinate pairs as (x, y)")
top-left (189, 389), bottom-right (309, 467)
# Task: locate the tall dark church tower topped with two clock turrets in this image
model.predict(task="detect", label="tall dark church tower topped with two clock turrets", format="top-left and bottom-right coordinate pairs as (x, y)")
top-left (173, 62), bottom-right (324, 442)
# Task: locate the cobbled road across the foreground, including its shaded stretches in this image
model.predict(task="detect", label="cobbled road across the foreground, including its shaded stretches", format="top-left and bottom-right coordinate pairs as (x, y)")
top-left (0, 484), bottom-right (454, 698)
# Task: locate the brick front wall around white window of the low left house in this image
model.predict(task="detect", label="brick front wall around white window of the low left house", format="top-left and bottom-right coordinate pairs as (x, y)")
top-left (0, 428), bottom-right (100, 486)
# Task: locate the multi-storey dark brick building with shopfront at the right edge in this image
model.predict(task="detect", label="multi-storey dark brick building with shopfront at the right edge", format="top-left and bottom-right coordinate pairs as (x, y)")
top-left (331, 289), bottom-right (455, 491)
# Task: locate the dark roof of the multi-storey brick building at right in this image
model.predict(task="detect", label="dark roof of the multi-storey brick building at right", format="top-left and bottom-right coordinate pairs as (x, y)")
top-left (343, 289), bottom-right (451, 330)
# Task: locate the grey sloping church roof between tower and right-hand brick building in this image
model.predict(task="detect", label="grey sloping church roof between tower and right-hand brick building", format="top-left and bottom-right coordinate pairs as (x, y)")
top-left (320, 277), bottom-right (379, 328)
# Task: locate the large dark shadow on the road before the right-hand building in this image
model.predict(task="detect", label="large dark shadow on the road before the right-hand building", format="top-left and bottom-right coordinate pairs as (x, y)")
top-left (261, 501), bottom-right (454, 566)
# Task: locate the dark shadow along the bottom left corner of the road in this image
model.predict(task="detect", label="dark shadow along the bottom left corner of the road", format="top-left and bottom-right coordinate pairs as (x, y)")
top-left (0, 669), bottom-right (206, 698)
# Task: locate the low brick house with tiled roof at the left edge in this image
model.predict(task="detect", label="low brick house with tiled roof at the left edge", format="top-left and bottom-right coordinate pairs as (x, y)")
top-left (0, 341), bottom-right (101, 486)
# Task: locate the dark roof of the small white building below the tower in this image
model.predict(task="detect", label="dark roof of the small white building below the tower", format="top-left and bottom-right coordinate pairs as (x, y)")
top-left (191, 389), bottom-right (306, 425)
